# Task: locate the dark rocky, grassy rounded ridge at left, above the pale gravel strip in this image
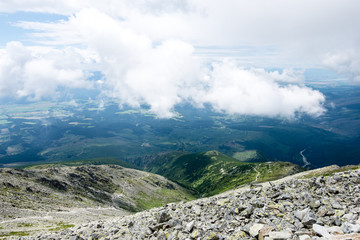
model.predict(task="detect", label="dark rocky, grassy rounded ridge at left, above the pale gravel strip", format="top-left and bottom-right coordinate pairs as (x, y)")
top-left (0, 165), bottom-right (191, 211)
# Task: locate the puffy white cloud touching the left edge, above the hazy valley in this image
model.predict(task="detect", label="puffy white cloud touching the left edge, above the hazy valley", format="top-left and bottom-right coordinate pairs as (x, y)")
top-left (0, 42), bottom-right (92, 100)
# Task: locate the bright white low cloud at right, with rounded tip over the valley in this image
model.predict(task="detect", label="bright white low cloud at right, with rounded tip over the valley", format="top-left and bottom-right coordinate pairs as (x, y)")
top-left (195, 63), bottom-right (325, 118)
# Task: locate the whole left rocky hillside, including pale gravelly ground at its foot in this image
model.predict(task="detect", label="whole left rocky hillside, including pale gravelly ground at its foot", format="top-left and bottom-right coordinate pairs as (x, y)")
top-left (0, 165), bottom-right (193, 237)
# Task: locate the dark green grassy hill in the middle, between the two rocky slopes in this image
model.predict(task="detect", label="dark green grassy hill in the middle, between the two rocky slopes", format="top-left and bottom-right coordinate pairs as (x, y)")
top-left (145, 151), bottom-right (301, 196)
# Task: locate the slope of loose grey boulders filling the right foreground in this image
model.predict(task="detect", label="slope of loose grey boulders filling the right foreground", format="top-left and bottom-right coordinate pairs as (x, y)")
top-left (7, 166), bottom-right (360, 240)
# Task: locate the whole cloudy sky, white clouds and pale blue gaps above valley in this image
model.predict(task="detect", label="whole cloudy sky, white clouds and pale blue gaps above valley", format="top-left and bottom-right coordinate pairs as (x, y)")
top-left (0, 0), bottom-right (360, 118)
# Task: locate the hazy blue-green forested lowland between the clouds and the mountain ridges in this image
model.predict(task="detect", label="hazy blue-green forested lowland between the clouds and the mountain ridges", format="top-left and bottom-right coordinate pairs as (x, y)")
top-left (0, 88), bottom-right (360, 168)
